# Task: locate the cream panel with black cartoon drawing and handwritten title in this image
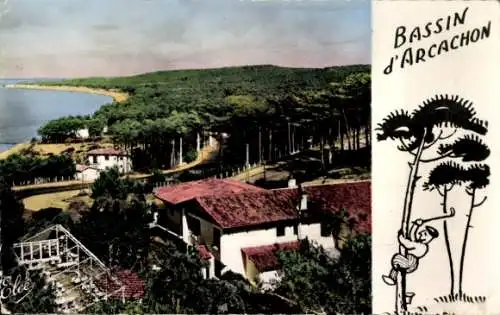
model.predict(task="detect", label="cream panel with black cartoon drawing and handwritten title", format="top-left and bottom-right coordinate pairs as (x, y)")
top-left (372, 1), bottom-right (500, 314)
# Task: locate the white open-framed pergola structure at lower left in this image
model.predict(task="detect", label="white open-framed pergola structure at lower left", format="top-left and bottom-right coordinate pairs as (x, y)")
top-left (13, 225), bottom-right (125, 313)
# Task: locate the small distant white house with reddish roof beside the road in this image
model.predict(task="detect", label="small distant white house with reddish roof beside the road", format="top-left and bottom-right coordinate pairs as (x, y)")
top-left (87, 149), bottom-right (132, 174)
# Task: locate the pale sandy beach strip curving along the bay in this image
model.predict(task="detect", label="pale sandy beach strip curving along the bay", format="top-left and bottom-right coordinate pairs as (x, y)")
top-left (3, 84), bottom-right (130, 103)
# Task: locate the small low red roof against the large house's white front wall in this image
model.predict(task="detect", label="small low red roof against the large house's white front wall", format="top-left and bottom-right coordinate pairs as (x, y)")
top-left (241, 241), bottom-right (299, 272)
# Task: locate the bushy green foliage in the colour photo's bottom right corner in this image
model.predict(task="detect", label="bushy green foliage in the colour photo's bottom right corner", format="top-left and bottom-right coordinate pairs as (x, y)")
top-left (276, 235), bottom-right (371, 314)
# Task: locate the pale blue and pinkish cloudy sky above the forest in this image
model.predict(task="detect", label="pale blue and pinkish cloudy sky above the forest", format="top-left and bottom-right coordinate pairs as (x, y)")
top-left (0, 0), bottom-right (371, 78)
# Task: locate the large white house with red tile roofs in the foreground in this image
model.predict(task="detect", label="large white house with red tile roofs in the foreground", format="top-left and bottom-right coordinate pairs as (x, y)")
top-left (155, 179), bottom-right (371, 286)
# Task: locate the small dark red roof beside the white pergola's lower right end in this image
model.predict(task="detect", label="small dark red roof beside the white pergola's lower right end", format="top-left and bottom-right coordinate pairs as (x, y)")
top-left (96, 270), bottom-right (146, 300)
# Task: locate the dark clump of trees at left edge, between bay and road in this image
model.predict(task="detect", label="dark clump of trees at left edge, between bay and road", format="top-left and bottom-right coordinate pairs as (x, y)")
top-left (0, 154), bottom-right (76, 184)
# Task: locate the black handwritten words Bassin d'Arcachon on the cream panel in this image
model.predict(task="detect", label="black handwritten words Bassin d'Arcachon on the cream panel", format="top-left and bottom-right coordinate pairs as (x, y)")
top-left (384, 7), bottom-right (491, 74)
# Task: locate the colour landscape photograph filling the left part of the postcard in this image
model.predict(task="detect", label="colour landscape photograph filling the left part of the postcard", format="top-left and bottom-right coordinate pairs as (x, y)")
top-left (0, 0), bottom-right (373, 314)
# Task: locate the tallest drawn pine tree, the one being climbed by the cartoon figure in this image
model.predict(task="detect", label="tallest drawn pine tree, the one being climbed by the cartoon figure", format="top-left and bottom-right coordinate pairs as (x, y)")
top-left (376, 95), bottom-right (487, 314)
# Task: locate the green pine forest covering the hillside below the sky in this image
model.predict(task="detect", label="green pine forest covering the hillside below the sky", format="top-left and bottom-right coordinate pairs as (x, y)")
top-left (37, 65), bottom-right (370, 170)
